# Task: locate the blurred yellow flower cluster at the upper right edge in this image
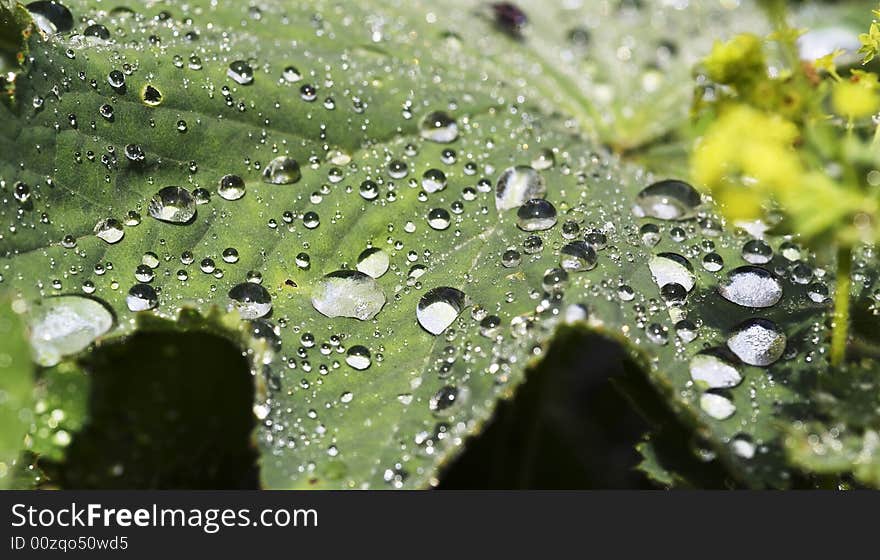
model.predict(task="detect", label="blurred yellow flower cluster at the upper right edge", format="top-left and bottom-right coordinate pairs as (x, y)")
top-left (691, 29), bottom-right (880, 246)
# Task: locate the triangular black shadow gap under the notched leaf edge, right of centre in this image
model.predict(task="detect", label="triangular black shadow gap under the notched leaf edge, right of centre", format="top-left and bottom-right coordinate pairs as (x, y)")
top-left (439, 330), bottom-right (653, 490)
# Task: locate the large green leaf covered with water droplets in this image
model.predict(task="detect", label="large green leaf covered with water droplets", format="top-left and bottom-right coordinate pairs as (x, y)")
top-left (0, 1), bottom-right (872, 488)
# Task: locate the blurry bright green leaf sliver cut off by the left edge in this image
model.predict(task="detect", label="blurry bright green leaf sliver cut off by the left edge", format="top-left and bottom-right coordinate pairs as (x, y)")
top-left (0, 299), bottom-right (34, 489)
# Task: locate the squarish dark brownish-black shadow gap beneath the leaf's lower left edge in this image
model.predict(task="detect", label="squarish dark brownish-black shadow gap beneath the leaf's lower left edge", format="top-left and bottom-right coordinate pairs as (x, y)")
top-left (47, 333), bottom-right (258, 489)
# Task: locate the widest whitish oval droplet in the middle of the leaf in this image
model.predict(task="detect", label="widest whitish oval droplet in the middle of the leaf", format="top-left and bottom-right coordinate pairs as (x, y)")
top-left (312, 270), bottom-right (385, 321)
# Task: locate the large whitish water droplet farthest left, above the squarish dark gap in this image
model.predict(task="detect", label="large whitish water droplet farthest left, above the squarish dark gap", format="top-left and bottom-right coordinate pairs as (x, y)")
top-left (28, 295), bottom-right (113, 367)
